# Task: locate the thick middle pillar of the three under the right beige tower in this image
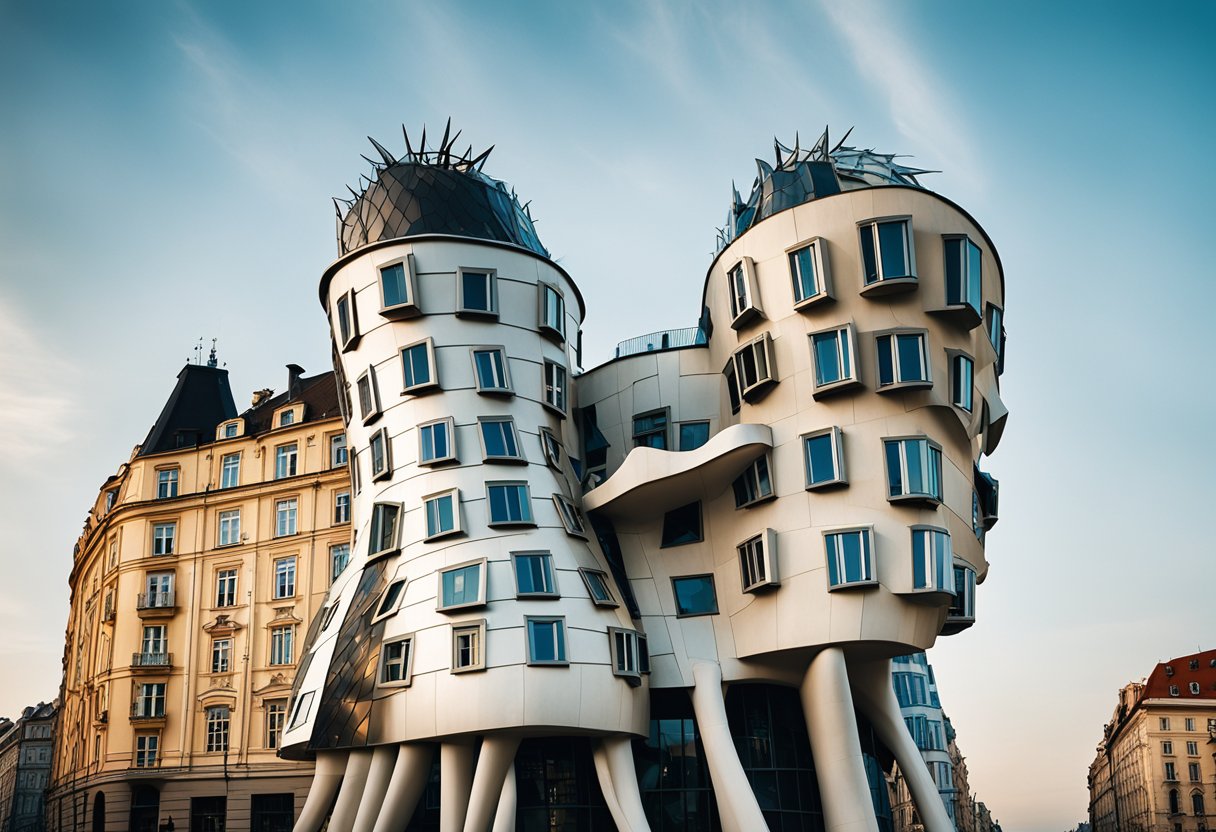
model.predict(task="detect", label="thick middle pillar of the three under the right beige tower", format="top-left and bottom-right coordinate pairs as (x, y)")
top-left (802, 647), bottom-right (878, 832)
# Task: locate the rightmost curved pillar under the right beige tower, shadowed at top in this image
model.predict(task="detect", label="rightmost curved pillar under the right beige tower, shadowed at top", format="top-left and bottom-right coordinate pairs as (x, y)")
top-left (849, 659), bottom-right (955, 832)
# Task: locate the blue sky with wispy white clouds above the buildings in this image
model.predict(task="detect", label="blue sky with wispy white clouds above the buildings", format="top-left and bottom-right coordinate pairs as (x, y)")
top-left (0, 0), bottom-right (1216, 832)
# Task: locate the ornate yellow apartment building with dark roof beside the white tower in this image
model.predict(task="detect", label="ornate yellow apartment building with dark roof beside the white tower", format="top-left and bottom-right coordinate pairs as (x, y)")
top-left (49, 360), bottom-right (350, 832)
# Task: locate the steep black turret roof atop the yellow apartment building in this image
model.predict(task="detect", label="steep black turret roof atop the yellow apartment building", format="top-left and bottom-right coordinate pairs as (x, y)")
top-left (140, 364), bottom-right (236, 456)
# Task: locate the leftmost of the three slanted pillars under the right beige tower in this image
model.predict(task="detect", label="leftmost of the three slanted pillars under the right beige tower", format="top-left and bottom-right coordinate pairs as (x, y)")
top-left (692, 662), bottom-right (763, 832)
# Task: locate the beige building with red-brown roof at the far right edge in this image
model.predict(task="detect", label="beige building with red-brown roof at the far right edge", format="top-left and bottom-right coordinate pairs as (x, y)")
top-left (1090, 650), bottom-right (1216, 832)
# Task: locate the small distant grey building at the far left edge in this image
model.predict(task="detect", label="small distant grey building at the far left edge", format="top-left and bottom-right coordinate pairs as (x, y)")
top-left (0, 702), bottom-right (56, 832)
